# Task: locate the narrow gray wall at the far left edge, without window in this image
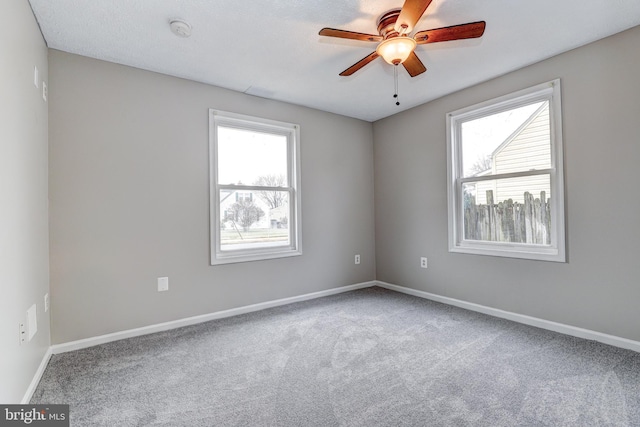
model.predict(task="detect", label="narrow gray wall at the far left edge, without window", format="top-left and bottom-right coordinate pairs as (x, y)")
top-left (0, 1), bottom-right (49, 403)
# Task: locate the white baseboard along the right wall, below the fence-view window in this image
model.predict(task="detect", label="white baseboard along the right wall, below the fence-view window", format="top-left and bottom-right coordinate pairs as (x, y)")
top-left (376, 281), bottom-right (640, 353)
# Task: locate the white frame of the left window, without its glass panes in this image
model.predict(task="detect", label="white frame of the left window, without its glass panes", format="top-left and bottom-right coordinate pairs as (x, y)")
top-left (209, 109), bottom-right (302, 265)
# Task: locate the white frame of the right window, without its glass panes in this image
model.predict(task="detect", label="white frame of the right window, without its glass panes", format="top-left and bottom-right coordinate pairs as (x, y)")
top-left (447, 79), bottom-right (566, 262)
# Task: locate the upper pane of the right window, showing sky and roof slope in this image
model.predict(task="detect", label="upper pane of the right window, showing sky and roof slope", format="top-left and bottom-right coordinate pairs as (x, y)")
top-left (461, 101), bottom-right (551, 177)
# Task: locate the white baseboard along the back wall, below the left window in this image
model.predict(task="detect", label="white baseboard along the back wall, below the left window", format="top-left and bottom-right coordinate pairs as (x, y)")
top-left (53, 281), bottom-right (376, 356)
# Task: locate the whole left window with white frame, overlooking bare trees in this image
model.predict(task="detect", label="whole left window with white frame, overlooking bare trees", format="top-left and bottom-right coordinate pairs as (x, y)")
top-left (209, 110), bottom-right (302, 265)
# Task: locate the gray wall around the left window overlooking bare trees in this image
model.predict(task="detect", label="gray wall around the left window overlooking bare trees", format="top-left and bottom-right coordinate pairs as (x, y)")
top-left (49, 50), bottom-right (375, 343)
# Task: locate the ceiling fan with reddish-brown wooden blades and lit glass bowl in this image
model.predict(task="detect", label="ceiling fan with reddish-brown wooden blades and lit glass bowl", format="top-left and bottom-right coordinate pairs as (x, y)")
top-left (319, 0), bottom-right (486, 77)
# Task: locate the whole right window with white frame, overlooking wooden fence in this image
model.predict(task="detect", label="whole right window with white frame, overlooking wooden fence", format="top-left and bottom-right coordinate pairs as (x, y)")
top-left (447, 80), bottom-right (565, 262)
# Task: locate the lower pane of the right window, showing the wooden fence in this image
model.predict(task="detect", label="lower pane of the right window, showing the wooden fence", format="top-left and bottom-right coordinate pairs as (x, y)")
top-left (462, 175), bottom-right (551, 245)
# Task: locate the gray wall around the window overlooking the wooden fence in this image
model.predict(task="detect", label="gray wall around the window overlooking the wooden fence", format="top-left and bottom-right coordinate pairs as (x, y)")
top-left (374, 27), bottom-right (640, 340)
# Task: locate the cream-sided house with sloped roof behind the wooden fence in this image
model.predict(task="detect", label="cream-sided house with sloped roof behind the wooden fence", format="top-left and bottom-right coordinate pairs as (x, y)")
top-left (475, 102), bottom-right (551, 204)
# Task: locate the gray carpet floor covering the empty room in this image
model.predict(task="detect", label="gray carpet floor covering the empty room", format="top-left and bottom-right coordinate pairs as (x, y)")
top-left (31, 288), bottom-right (640, 427)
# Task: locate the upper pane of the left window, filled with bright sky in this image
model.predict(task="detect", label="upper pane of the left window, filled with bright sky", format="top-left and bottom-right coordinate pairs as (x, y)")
top-left (217, 126), bottom-right (288, 187)
